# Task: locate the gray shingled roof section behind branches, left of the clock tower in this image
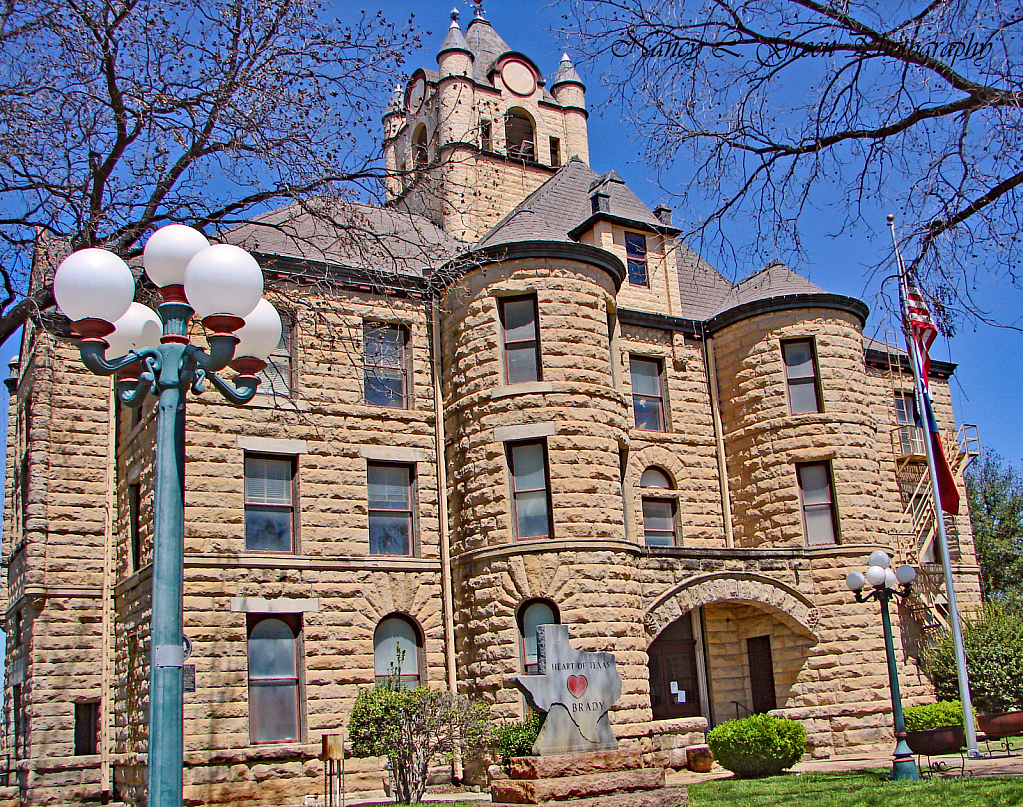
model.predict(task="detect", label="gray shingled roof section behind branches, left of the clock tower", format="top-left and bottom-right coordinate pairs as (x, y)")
top-left (221, 199), bottom-right (469, 276)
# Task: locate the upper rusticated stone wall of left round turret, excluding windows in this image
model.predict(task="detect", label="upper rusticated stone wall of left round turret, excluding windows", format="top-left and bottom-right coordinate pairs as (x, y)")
top-left (442, 259), bottom-right (625, 553)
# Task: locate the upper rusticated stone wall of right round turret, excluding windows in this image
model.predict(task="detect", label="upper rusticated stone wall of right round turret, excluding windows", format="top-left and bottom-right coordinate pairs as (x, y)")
top-left (713, 310), bottom-right (899, 547)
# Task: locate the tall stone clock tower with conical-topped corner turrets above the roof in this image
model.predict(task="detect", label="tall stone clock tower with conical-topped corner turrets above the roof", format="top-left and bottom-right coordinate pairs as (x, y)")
top-left (384, 7), bottom-right (589, 241)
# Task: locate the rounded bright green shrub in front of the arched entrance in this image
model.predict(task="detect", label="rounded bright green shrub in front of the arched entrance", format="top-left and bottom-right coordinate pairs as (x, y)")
top-left (707, 715), bottom-right (806, 778)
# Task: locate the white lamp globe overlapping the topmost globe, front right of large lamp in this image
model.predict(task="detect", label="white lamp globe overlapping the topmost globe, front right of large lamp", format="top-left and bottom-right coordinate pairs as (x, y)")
top-left (184, 243), bottom-right (263, 319)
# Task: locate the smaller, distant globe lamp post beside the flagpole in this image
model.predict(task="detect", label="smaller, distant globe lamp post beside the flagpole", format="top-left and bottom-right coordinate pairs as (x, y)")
top-left (845, 549), bottom-right (920, 781)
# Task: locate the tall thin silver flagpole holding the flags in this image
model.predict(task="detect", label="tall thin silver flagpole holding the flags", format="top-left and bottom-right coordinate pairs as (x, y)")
top-left (888, 214), bottom-right (982, 759)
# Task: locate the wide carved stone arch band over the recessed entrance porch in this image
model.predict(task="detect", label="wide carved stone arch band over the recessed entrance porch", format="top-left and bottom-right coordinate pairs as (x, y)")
top-left (644, 572), bottom-right (818, 641)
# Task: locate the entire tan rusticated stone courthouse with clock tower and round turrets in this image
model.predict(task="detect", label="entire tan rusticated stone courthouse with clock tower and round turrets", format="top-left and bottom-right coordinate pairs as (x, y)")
top-left (3, 7), bottom-right (979, 806)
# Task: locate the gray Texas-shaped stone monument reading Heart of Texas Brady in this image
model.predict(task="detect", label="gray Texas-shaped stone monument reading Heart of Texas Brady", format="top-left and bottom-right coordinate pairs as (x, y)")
top-left (512, 625), bottom-right (622, 756)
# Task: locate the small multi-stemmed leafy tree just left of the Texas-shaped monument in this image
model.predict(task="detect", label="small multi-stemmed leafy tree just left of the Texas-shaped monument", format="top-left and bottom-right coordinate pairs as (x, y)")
top-left (348, 684), bottom-right (491, 804)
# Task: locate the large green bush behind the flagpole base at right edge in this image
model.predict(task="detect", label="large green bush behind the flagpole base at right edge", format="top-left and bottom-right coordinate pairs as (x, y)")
top-left (924, 606), bottom-right (1023, 714)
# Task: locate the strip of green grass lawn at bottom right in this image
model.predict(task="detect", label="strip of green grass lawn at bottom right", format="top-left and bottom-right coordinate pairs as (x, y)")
top-left (687, 771), bottom-right (1023, 807)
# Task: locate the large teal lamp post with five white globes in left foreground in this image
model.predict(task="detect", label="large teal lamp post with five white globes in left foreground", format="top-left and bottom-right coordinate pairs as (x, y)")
top-left (53, 225), bottom-right (281, 807)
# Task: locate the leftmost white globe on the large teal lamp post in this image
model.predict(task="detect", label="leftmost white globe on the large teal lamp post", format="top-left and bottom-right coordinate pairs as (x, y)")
top-left (53, 249), bottom-right (135, 322)
